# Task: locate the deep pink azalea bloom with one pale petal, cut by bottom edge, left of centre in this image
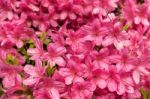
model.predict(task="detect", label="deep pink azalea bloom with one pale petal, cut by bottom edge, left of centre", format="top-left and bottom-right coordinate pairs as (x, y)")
top-left (33, 78), bottom-right (64, 99)
